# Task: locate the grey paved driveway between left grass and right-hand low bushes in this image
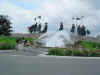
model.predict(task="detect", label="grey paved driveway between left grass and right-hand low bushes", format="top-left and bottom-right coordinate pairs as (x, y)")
top-left (0, 47), bottom-right (48, 56)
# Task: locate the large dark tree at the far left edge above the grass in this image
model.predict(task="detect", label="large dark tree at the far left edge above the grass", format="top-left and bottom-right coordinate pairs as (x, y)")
top-left (0, 15), bottom-right (12, 36)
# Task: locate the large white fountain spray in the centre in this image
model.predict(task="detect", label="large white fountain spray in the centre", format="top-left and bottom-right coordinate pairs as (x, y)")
top-left (35, 30), bottom-right (74, 48)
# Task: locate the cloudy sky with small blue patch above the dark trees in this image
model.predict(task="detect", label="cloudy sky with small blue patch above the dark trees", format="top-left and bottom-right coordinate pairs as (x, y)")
top-left (0, 0), bottom-right (100, 35)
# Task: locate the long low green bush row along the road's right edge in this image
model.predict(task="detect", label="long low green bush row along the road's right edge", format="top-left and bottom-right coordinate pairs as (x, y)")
top-left (48, 48), bottom-right (100, 57)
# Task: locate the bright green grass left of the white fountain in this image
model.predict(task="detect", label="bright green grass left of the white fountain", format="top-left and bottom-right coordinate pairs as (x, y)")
top-left (0, 36), bottom-right (35, 50)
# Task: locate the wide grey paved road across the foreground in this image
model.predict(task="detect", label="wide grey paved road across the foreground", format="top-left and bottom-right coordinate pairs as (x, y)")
top-left (0, 55), bottom-right (100, 75)
